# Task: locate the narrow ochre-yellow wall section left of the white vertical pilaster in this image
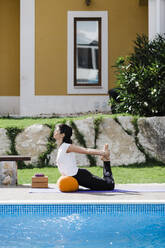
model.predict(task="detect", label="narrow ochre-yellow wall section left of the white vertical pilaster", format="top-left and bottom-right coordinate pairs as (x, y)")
top-left (0, 0), bottom-right (20, 96)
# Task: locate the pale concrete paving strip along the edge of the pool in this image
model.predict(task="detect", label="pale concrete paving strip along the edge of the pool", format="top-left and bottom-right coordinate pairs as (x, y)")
top-left (0, 183), bottom-right (165, 204)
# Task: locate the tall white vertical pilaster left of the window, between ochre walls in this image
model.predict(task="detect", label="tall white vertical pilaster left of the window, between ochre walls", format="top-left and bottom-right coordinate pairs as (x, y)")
top-left (20, 0), bottom-right (35, 115)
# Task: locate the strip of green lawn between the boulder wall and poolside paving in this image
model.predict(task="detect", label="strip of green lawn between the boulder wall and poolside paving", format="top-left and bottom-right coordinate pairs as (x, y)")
top-left (18, 166), bottom-right (165, 184)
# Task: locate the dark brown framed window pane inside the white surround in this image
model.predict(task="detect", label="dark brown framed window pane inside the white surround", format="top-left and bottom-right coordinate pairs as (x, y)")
top-left (74, 18), bottom-right (101, 86)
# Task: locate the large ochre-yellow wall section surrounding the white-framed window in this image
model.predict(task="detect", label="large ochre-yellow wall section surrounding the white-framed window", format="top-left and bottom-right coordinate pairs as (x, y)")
top-left (35, 0), bottom-right (148, 95)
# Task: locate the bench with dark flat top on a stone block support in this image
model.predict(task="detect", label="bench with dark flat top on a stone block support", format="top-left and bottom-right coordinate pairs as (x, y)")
top-left (0, 155), bottom-right (31, 185)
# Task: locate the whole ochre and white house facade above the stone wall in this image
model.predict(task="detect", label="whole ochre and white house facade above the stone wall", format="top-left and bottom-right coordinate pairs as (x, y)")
top-left (0, 0), bottom-right (165, 116)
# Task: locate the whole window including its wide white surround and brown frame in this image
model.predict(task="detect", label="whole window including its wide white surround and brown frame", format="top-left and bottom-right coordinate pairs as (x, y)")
top-left (68, 11), bottom-right (108, 94)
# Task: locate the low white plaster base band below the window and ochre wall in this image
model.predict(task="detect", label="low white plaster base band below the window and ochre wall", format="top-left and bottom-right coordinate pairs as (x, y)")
top-left (21, 96), bottom-right (110, 116)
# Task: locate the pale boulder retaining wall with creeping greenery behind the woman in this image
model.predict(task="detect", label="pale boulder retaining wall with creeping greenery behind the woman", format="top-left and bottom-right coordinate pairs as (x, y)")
top-left (0, 116), bottom-right (165, 176)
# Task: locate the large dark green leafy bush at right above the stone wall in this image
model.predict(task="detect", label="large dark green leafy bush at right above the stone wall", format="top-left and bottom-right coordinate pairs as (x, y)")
top-left (110, 35), bottom-right (165, 116)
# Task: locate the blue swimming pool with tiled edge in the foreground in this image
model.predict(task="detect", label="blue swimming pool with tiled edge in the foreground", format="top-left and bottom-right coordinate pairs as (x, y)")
top-left (0, 204), bottom-right (165, 248)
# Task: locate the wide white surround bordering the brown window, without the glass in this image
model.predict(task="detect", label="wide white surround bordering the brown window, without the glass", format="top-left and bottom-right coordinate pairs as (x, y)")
top-left (67, 11), bottom-right (108, 94)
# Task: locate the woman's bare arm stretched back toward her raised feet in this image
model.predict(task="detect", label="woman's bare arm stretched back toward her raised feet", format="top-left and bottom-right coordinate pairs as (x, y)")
top-left (67, 145), bottom-right (105, 156)
